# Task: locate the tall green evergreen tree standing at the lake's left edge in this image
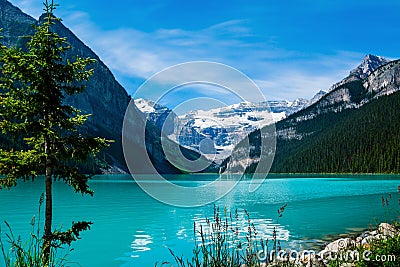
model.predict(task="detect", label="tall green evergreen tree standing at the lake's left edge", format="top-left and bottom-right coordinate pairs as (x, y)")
top-left (0, 0), bottom-right (109, 266)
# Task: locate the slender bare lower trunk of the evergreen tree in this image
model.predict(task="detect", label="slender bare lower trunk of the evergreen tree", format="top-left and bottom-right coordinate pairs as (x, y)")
top-left (42, 142), bottom-right (53, 266)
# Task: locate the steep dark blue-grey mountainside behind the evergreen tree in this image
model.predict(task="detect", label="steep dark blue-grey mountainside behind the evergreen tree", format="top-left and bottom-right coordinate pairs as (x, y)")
top-left (0, 0), bottom-right (130, 169)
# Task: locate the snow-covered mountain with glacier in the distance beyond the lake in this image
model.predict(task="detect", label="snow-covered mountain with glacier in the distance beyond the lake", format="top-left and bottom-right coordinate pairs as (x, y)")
top-left (135, 91), bottom-right (325, 162)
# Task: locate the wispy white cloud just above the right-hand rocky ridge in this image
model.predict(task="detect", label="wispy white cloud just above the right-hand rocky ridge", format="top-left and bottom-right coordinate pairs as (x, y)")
top-left (255, 51), bottom-right (364, 100)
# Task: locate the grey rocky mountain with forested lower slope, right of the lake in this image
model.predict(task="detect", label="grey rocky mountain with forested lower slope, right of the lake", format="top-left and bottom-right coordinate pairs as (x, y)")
top-left (221, 55), bottom-right (400, 172)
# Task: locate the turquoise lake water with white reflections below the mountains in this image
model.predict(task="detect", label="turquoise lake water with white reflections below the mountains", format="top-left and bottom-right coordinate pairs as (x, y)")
top-left (0, 175), bottom-right (400, 267)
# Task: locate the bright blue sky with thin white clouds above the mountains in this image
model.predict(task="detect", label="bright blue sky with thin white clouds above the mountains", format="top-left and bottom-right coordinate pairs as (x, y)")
top-left (11, 0), bottom-right (400, 109)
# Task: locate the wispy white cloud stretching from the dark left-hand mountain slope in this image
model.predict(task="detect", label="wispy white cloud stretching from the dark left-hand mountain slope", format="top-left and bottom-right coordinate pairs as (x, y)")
top-left (64, 13), bottom-right (258, 78)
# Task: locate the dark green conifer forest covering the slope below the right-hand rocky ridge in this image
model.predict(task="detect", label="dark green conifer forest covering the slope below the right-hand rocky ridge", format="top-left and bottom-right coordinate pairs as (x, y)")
top-left (268, 92), bottom-right (400, 173)
